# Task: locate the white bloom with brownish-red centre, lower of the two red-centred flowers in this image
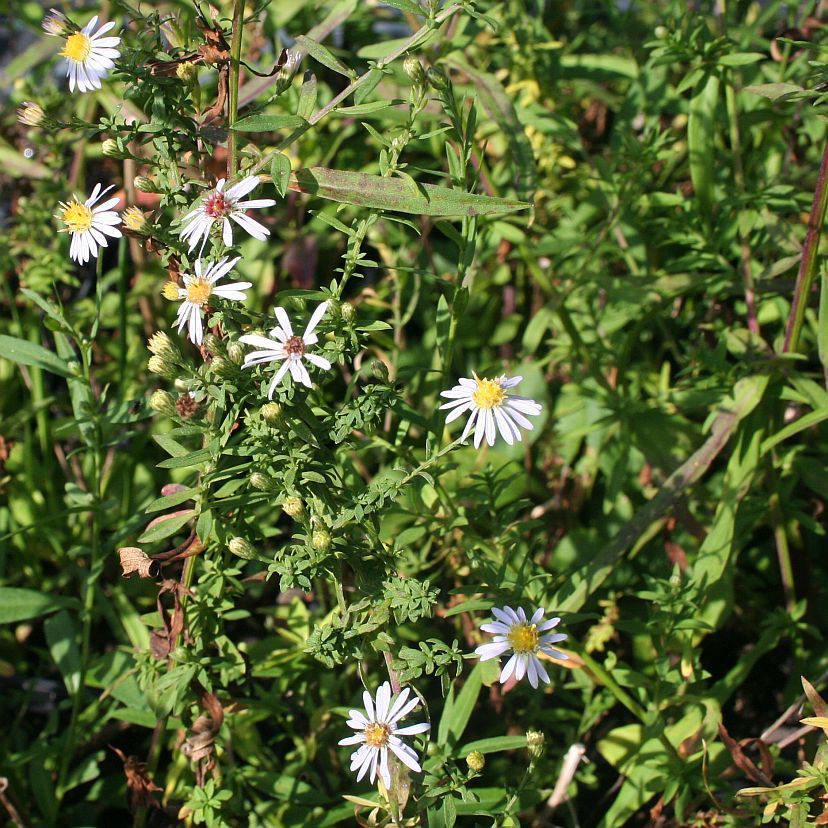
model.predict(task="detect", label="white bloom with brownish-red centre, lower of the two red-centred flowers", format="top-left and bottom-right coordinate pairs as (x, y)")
top-left (239, 302), bottom-right (331, 399)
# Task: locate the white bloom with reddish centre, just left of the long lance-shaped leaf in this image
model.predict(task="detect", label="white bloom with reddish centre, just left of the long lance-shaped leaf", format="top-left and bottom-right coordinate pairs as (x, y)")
top-left (179, 175), bottom-right (276, 250)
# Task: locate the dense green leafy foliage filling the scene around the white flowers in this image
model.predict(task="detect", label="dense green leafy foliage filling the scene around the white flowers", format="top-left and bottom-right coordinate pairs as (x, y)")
top-left (0, 0), bottom-right (828, 828)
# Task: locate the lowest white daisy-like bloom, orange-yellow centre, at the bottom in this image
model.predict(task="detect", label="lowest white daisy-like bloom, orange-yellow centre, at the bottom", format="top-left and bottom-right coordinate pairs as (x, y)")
top-left (339, 681), bottom-right (431, 788)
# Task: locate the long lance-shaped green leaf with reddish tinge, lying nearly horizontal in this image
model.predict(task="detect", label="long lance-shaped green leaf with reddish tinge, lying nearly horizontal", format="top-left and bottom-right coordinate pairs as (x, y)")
top-left (290, 167), bottom-right (530, 216)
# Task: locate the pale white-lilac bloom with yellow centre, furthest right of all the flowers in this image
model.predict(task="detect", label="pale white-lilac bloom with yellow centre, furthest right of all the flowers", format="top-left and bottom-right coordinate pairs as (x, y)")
top-left (474, 607), bottom-right (569, 687)
